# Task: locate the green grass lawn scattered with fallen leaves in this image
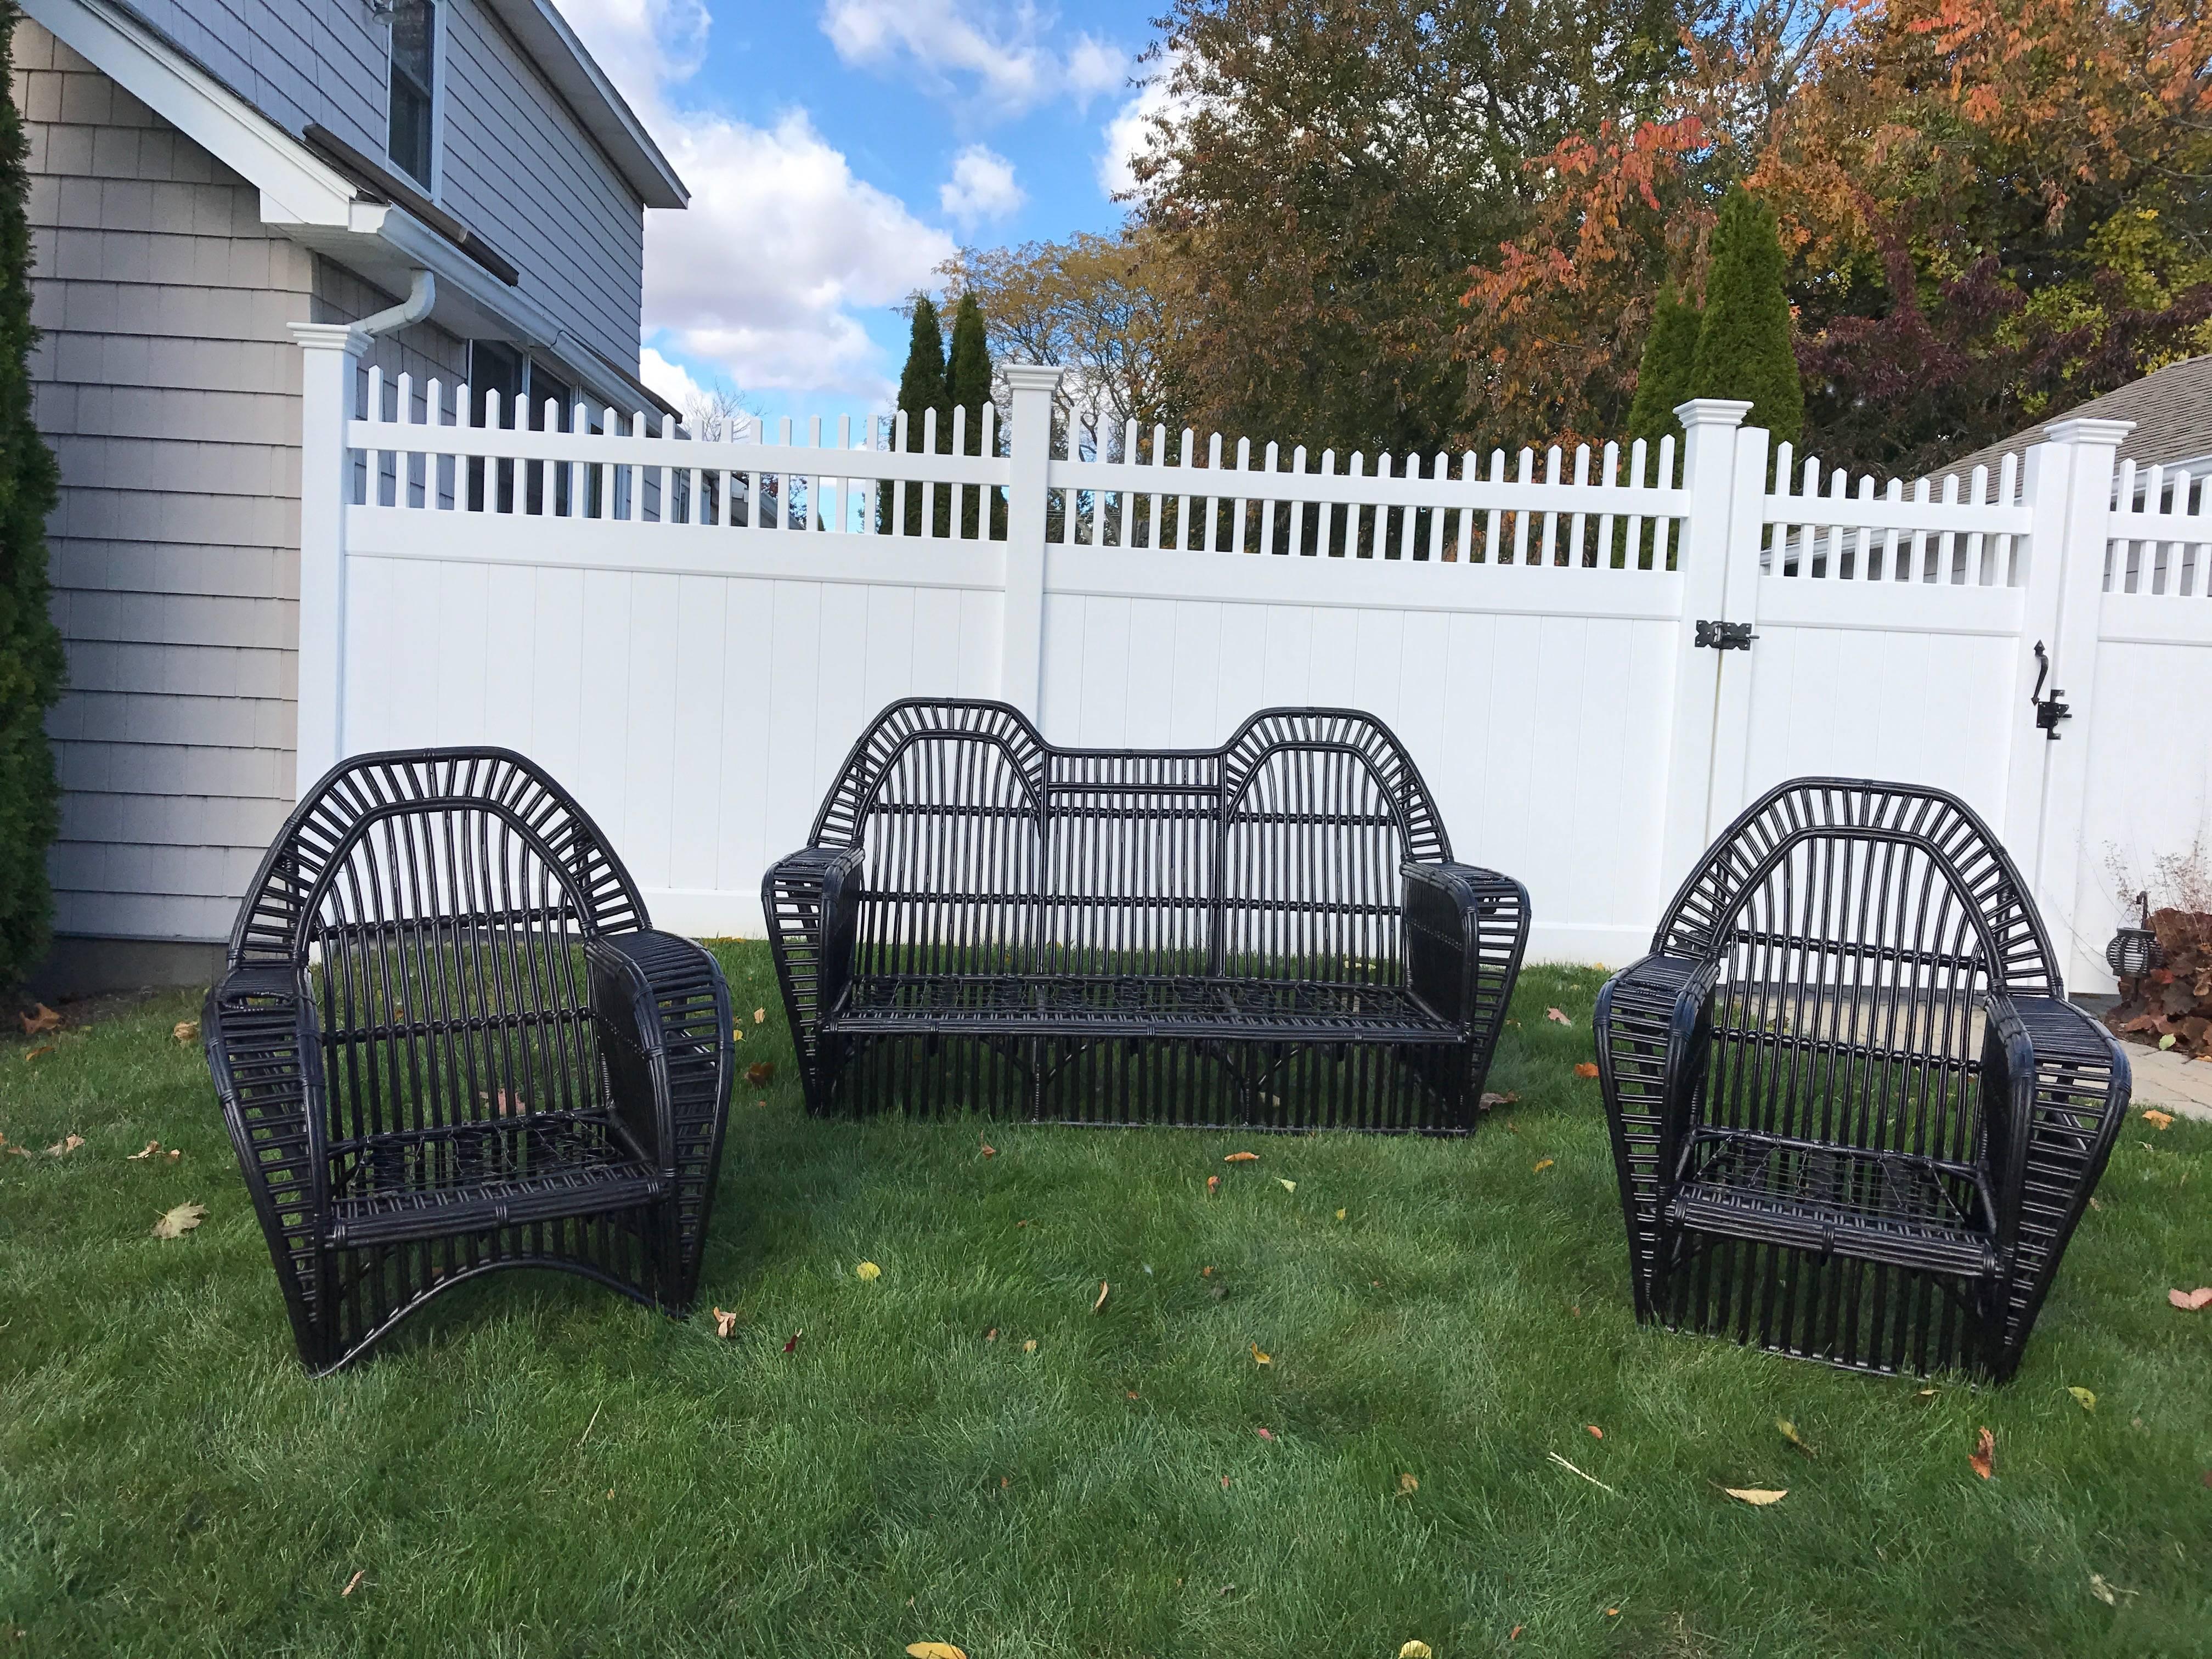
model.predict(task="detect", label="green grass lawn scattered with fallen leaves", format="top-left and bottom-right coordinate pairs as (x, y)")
top-left (0, 945), bottom-right (2212, 1659)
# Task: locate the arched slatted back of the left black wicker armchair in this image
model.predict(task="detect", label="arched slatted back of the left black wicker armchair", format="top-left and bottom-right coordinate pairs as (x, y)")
top-left (230, 748), bottom-right (646, 1192)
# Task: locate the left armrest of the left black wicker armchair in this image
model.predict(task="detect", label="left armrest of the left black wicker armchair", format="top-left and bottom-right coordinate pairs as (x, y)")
top-left (199, 967), bottom-right (330, 1323)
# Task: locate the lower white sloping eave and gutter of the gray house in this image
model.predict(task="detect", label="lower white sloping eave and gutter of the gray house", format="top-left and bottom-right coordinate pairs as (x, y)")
top-left (24, 0), bottom-right (681, 414)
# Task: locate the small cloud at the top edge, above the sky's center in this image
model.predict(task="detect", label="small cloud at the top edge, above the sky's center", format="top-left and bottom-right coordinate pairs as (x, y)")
top-left (823, 0), bottom-right (1128, 117)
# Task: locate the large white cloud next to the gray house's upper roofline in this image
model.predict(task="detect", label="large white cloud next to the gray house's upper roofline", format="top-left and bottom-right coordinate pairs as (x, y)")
top-left (564, 0), bottom-right (955, 400)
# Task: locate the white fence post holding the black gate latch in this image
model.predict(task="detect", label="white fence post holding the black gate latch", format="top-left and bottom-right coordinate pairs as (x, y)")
top-left (2004, 420), bottom-right (2135, 989)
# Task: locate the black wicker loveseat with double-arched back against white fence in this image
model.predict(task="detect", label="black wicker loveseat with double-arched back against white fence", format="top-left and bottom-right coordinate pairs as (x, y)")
top-left (763, 699), bottom-right (1528, 1132)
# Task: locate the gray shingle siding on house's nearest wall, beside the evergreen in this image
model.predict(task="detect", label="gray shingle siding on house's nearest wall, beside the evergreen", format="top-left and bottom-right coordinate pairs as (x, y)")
top-left (13, 22), bottom-right (462, 940)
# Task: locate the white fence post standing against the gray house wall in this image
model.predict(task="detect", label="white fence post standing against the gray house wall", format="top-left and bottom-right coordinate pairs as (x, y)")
top-left (292, 323), bottom-right (367, 799)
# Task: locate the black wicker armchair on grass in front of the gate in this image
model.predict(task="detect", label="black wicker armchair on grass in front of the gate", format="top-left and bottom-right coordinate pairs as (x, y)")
top-left (1597, 778), bottom-right (2128, 1380)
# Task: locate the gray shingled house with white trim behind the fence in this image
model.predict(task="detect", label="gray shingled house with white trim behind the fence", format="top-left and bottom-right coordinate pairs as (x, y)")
top-left (13, 0), bottom-right (686, 991)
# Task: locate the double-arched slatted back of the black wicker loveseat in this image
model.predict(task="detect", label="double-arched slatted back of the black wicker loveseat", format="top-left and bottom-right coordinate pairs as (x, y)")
top-left (812, 699), bottom-right (1451, 982)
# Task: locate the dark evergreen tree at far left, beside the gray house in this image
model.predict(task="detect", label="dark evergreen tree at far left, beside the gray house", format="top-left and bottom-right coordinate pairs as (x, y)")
top-left (0, 0), bottom-right (62, 986)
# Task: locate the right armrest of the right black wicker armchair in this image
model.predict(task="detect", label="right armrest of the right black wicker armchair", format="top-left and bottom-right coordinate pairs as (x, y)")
top-left (1982, 995), bottom-right (2132, 1374)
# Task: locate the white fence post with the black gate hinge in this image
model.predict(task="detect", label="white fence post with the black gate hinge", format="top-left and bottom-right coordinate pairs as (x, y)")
top-left (1652, 398), bottom-right (1752, 920)
